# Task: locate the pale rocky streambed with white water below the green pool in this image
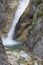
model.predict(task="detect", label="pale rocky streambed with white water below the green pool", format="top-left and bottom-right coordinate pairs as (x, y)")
top-left (6, 47), bottom-right (43, 65)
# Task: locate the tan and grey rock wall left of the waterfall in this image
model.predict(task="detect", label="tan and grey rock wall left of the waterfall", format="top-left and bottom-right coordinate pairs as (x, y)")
top-left (0, 0), bottom-right (19, 34)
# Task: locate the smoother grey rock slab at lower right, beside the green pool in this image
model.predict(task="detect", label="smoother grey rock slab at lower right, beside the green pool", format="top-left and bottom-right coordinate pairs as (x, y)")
top-left (26, 19), bottom-right (43, 58)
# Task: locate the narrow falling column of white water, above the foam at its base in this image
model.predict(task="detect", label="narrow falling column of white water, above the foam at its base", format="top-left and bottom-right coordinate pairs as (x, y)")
top-left (8, 0), bottom-right (29, 39)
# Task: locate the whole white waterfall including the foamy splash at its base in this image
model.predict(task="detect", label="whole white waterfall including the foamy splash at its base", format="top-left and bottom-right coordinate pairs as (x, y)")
top-left (2, 0), bottom-right (30, 46)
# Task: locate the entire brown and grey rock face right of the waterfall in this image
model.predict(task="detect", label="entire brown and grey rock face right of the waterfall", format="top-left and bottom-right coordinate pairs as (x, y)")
top-left (16, 0), bottom-right (43, 58)
